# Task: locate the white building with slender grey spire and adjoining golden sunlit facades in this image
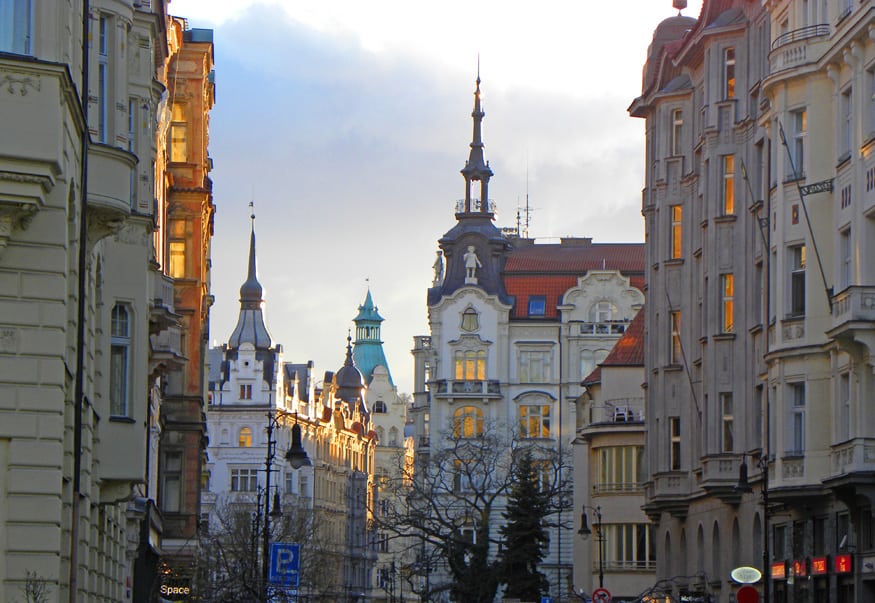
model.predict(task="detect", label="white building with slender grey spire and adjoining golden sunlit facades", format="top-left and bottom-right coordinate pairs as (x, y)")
top-left (202, 224), bottom-right (379, 601)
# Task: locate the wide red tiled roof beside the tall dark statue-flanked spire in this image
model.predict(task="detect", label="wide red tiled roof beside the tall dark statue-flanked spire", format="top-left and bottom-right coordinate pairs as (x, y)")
top-left (504, 243), bottom-right (644, 319)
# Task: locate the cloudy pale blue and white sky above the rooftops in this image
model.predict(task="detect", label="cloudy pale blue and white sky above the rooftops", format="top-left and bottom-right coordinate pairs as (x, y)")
top-left (169, 0), bottom-right (701, 393)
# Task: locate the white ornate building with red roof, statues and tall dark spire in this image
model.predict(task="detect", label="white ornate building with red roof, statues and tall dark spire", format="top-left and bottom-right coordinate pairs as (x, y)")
top-left (412, 78), bottom-right (644, 600)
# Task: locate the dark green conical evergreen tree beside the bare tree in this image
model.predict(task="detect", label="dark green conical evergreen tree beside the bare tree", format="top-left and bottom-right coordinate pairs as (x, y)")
top-left (500, 451), bottom-right (551, 601)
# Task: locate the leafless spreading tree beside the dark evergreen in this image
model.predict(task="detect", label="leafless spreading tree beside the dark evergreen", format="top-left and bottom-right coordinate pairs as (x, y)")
top-left (375, 426), bottom-right (571, 603)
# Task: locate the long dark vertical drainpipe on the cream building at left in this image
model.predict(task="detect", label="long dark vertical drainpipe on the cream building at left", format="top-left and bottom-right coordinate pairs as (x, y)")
top-left (69, 0), bottom-right (91, 603)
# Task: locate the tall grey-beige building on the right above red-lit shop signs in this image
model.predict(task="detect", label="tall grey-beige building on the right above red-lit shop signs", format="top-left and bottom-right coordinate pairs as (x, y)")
top-left (630, 0), bottom-right (875, 602)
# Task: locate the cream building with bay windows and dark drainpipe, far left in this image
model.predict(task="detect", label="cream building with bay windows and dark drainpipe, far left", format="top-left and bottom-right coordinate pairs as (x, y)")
top-left (0, 0), bottom-right (211, 601)
